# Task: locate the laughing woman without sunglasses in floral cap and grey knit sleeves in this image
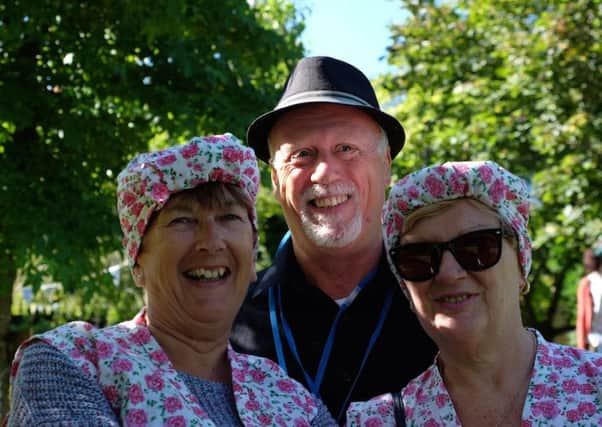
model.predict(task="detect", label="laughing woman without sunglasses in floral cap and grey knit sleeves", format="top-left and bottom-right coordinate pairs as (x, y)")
top-left (8, 134), bottom-right (336, 426)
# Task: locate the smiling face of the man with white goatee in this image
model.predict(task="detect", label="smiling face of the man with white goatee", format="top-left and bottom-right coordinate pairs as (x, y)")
top-left (269, 104), bottom-right (391, 254)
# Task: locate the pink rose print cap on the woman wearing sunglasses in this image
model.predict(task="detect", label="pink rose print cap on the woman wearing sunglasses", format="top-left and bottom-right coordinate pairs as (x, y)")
top-left (382, 161), bottom-right (531, 283)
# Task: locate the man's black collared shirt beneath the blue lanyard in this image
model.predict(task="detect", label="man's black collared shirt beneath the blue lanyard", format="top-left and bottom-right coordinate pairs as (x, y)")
top-left (231, 240), bottom-right (436, 422)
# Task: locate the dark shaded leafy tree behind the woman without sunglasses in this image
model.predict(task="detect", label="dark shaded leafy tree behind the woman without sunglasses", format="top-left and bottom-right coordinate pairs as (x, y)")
top-left (0, 0), bottom-right (303, 415)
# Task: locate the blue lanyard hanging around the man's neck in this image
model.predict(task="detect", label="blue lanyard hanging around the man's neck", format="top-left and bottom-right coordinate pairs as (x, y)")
top-left (268, 260), bottom-right (393, 404)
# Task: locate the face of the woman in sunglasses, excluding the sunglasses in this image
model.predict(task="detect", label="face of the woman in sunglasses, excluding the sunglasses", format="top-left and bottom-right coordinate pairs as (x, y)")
top-left (401, 199), bottom-right (522, 342)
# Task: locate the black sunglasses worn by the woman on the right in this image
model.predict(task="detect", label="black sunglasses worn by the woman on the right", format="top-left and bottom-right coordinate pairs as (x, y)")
top-left (390, 228), bottom-right (511, 282)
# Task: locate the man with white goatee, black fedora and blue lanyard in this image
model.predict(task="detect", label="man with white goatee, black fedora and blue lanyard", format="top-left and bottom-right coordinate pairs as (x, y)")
top-left (231, 57), bottom-right (435, 422)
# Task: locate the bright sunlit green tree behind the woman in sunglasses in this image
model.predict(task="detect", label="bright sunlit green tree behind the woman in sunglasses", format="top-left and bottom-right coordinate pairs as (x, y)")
top-left (379, 0), bottom-right (602, 338)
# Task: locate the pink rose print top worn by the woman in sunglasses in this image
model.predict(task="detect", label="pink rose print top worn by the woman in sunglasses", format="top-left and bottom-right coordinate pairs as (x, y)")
top-left (347, 331), bottom-right (602, 427)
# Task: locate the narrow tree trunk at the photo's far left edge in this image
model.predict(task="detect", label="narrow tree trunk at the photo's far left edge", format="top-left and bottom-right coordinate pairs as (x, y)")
top-left (0, 253), bottom-right (17, 421)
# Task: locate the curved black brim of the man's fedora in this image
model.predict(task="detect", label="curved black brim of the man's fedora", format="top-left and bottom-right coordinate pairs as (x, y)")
top-left (247, 97), bottom-right (406, 163)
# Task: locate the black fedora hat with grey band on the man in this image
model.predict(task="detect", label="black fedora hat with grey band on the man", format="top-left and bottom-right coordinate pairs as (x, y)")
top-left (247, 56), bottom-right (405, 162)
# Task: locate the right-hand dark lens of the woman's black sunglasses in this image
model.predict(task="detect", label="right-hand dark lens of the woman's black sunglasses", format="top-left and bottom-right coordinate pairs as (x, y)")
top-left (450, 230), bottom-right (501, 271)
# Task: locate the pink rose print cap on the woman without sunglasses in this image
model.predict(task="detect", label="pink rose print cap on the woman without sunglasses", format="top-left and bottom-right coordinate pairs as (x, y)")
top-left (117, 133), bottom-right (259, 267)
